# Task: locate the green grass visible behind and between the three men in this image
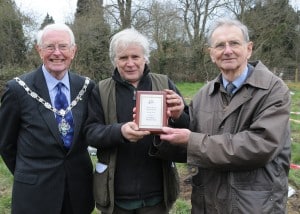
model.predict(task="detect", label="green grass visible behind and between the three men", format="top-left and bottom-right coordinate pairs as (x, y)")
top-left (0, 83), bottom-right (300, 214)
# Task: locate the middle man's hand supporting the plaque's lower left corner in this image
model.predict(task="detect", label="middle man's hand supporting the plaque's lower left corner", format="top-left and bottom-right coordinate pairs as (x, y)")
top-left (121, 122), bottom-right (150, 142)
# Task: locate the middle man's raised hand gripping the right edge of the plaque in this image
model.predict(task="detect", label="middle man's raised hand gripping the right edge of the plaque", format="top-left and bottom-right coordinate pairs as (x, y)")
top-left (164, 89), bottom-right (184, 119)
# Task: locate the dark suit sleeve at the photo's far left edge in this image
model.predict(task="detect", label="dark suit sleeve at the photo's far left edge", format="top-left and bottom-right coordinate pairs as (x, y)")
top-left (0, 83), bottom-right (20, 174)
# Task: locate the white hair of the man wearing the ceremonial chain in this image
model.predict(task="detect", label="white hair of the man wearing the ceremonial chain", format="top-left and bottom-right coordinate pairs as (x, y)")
top-left (36, 23), bottom-right (75, 46)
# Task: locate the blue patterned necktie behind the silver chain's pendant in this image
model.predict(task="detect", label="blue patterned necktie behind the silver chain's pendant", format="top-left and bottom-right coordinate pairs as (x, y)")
top-left (54, 82), bottom-right (74, 148)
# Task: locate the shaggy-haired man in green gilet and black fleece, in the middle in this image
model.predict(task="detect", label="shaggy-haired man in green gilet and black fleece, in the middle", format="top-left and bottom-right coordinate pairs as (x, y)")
top-left (85, 29), bottom-right (189, 214)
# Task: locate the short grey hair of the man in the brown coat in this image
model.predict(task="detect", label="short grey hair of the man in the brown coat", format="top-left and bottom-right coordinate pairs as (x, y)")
top-left (207, 18), bottom-right (250, 46)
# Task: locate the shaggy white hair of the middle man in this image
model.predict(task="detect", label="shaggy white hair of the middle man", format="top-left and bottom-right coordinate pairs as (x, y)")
top-left (109, 28), bottom-right (150, 66)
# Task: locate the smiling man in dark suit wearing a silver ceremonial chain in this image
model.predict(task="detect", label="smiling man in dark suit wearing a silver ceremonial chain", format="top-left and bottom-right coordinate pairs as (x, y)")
top-left (0, 24), bottom-right (94, 214)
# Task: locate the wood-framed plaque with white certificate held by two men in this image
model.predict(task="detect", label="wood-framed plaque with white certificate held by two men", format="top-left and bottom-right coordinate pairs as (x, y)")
top-left (135, 91), bottom-right (167, 133)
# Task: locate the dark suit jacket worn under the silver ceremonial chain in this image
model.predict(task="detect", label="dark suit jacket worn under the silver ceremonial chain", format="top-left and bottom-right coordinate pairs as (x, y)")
top-left (0, 67), bottom-right (94, 214)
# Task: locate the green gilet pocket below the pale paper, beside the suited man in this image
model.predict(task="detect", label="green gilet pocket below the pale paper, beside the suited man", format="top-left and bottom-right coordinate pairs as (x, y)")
top-left (93, 163), bottom-right (110, 207)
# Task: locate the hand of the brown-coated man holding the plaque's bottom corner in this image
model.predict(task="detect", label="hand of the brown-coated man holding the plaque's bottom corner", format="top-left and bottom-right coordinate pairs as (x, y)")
top-left (160, 127), bottom-right (191, 144)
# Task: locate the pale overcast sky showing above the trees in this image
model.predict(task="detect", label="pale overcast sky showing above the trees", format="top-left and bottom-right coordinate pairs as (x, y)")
top-left (14, 0), bottom-right (300, 23)
